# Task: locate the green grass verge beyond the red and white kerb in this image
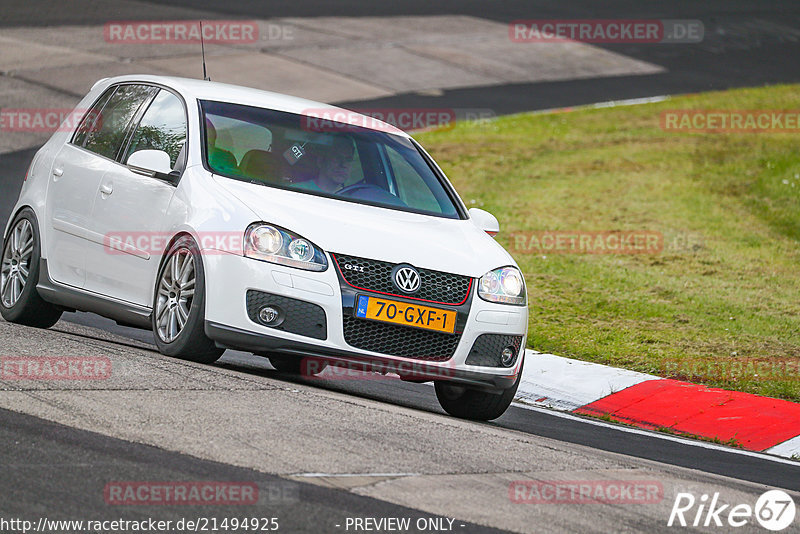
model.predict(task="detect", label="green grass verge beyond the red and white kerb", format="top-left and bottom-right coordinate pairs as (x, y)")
top-left (418, 85), bottom-right (800, 401)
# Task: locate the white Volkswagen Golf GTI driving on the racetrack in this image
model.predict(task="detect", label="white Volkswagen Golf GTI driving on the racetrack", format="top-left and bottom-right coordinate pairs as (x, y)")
top-left (0, 76), bottom-right (528, 420)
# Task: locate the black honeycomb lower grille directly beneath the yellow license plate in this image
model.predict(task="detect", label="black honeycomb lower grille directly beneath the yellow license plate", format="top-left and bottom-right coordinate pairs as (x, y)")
top-left (344, 314), bottom-right (461, 362)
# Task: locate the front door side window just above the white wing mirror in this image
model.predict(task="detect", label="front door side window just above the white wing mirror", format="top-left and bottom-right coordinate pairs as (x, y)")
top-left (123, 89), bottom-right (187, 169)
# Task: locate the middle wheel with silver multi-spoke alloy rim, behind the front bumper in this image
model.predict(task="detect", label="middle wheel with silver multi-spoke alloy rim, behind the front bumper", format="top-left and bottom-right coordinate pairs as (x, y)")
top-left (152, 236), bottom-right (225, 363)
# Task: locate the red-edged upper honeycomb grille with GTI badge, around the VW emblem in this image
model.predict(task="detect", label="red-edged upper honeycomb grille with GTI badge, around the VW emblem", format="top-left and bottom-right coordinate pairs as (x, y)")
top-left (333, 254), bottom-right (472, 305)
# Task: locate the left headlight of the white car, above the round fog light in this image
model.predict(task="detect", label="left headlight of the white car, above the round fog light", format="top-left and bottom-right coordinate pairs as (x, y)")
top-left (244, 223), bottom-right (328, 271)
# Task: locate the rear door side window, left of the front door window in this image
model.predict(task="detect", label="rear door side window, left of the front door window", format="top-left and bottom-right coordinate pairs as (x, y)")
top-left (81, 85), bottom-right (157, 159)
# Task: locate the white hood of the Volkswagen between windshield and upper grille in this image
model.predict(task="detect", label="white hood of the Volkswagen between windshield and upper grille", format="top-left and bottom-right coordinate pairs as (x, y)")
top-left (215, 176), bottom-right (515, 277)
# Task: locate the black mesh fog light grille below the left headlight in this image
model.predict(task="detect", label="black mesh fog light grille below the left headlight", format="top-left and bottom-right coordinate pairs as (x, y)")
top-left (247, 289), bottom-right (328, 339)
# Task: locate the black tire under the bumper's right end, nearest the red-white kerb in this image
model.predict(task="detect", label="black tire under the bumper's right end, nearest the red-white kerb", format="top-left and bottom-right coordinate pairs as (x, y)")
top-left (434, 360), bottom-right (522, 421)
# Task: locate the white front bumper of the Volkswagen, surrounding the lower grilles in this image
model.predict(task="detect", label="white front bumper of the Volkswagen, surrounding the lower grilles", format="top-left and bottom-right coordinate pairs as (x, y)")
top-left (204, 253), bottom-right (528, 390)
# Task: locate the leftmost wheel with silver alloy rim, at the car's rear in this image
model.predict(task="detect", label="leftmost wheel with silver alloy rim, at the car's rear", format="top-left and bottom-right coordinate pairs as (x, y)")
top-left (0, 209), bottom-right (63, 328)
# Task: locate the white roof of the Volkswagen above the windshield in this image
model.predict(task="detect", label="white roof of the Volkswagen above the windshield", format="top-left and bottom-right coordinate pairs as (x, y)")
top-left (93, 74), bottom-right (410, 137)
